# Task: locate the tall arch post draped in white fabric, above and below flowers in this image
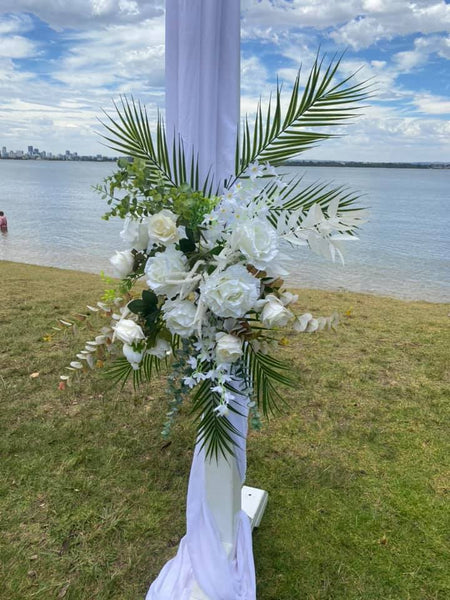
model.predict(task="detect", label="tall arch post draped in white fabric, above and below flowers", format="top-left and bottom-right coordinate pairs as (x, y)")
top-left (147, 0), bottom-right (267, 600)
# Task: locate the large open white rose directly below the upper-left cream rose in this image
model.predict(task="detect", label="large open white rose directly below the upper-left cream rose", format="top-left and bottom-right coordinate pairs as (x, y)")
top-left (145, 246), bottom-right (186, 298)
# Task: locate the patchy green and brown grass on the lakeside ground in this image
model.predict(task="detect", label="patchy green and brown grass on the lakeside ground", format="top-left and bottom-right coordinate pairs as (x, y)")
top-left (0, 262), bottom-right (450, 600)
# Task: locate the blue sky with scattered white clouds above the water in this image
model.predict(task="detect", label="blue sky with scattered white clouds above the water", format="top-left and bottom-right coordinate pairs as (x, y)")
top-left (0, 0), bottom-right (450, 162)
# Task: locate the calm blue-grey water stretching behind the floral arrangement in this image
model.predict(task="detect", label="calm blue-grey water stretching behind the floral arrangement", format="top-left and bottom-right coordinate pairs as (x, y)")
top-left (0, 160), bottom-right (450, 302)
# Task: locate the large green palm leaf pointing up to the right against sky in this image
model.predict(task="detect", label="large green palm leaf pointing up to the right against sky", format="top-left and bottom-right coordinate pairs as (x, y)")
top-left (235, 58), bottom-right (368, 177)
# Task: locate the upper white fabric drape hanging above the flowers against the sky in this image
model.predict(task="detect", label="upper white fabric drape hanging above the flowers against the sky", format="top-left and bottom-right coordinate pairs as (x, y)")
top-left (166, 0), bottom-right (240, 188)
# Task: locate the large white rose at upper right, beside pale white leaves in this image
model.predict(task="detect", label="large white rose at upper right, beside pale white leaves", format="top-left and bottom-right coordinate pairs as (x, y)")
top-left (230, 218), bottom-right (278, 269)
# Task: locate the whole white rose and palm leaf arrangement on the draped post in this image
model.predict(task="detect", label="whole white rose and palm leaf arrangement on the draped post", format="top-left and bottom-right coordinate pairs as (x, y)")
top-left (62, 57), bottom-right (365, 456)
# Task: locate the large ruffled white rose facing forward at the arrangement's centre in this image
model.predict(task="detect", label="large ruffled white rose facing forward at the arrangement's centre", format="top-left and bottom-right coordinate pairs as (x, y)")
top-left (200, 265), bottom-right (261, 318)
